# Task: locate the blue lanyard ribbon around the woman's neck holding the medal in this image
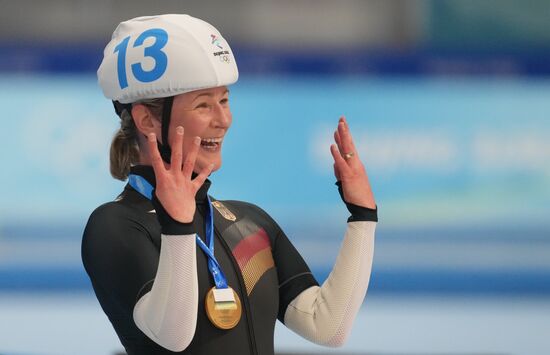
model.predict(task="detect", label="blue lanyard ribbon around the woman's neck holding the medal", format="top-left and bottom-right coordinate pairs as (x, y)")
top-left (128, 174), bottom-right (227, 289)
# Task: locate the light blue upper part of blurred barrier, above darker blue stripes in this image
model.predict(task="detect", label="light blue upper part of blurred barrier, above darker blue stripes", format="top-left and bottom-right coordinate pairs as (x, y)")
top-left (4, 75), bottom-right (550, 227)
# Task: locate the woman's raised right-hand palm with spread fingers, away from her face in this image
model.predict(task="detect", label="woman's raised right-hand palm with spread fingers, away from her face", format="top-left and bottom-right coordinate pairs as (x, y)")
top-left (330, 116), bottom-right (376, 209)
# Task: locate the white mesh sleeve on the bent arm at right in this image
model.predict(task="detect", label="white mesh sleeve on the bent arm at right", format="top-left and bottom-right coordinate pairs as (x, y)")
top-left (284, 221), bottom-right (376, 347)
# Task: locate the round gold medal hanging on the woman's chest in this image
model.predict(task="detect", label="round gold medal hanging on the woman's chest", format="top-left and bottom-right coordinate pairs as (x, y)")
top-left (204, 287), bottom-right (242, 329)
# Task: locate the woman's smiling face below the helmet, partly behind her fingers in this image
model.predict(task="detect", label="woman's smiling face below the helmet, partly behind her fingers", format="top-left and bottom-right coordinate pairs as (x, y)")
top-left (168, 86), bottom-right (232, 173)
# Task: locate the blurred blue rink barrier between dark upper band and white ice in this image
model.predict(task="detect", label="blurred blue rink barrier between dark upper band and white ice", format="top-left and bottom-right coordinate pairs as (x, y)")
top-left (0, 75), bottom-right (550, 295)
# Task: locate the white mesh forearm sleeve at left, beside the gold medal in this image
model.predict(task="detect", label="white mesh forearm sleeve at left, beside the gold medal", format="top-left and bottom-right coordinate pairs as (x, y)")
top-left (133, 234), bottom-right (198, 352)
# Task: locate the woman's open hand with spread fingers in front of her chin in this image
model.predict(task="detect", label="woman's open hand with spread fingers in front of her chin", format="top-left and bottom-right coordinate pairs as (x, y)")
top-left (147, 126), bottom-right (214, 223)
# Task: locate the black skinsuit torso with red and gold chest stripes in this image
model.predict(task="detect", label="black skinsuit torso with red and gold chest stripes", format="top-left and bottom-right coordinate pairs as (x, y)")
top-left (82, 166), bottom-right (318, 355)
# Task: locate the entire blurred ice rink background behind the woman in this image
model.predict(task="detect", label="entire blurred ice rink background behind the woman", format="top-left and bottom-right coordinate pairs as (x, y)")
top-left (0, 0), bottom-right (550, 355)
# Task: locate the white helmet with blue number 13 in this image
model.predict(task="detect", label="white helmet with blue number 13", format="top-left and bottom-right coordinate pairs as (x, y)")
top-left (97, 14), bottom-right (239, 104)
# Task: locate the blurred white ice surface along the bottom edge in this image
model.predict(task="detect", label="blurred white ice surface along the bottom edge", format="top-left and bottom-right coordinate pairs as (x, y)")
top-left (0, 293), bottom-right (550, 355)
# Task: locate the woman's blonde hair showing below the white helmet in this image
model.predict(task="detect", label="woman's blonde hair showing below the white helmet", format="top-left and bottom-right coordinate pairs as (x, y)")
top-left (109, 98), bottom-right (164, 181)
